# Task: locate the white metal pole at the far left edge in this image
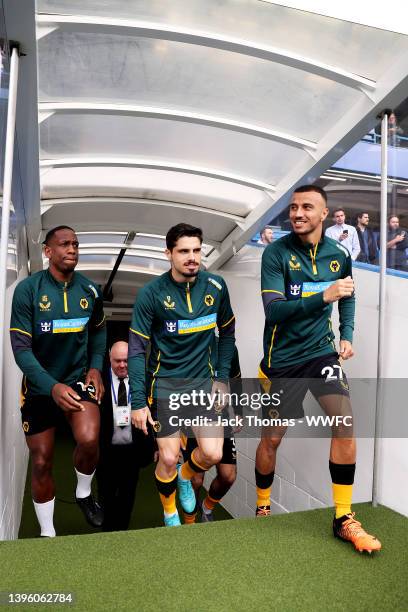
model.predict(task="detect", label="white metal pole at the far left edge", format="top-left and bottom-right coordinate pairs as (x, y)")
top-left (0, 48), bottom-right (19, 418)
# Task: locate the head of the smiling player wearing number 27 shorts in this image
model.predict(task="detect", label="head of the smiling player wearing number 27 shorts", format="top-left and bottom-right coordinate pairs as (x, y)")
top-left (289, 191), bottom-right (329, 242)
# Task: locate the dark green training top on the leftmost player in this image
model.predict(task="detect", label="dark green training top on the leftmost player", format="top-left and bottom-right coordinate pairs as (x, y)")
top-left (10, 270), bottom-right (106, 395)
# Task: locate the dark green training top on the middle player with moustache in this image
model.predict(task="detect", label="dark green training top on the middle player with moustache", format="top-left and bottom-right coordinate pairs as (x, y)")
top-left (128, 271), bottom-right (235, 410)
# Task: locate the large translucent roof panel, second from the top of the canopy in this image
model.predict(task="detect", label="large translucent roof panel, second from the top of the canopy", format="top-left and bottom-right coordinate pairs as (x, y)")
top-left (39, 30), bottom-right (363, 141)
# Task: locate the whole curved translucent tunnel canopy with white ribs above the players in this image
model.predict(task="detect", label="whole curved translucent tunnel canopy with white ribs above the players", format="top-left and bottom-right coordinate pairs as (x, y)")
top-left (37, 0), bottom-right (408, 303)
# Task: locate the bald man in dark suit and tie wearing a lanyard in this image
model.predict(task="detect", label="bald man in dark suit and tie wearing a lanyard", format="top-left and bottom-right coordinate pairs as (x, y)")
top-left (96, 341), bottom-right (153, 531)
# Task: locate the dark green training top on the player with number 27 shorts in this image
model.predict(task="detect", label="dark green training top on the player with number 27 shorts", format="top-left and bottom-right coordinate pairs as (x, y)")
top-left (261, 232), bottom-right (355, 374)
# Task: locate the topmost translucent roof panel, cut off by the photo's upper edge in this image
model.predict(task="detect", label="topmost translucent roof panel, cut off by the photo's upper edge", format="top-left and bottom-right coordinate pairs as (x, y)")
top-left (37, 0), bottom-right (406, 80)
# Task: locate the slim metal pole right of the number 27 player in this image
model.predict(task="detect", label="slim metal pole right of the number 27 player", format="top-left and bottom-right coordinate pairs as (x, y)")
top-left (372, 111), bottom-right (389, 507)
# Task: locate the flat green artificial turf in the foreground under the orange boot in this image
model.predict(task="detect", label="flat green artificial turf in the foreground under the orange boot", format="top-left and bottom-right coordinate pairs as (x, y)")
top-left (0, 504), bottom-right (408, 612)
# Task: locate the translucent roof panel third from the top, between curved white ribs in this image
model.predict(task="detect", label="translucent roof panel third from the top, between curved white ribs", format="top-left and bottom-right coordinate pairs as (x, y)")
top-left (40, 113), bottom-right (302, 184)
